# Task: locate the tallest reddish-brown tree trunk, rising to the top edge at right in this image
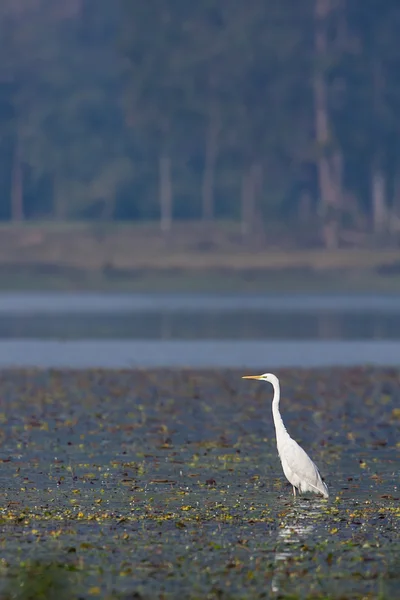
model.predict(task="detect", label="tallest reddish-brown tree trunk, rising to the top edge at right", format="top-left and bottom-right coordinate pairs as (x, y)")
top-left (314, 0), bottom-right (341, 248)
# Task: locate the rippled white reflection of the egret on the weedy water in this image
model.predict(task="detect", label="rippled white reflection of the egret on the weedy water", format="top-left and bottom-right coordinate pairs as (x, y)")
top-left (271, 498), bottom-right (326, 594)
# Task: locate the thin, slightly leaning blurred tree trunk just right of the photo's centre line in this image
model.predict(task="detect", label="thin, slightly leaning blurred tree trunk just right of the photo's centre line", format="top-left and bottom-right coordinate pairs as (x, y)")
top-left (202, 102), bottom-right (219, 221)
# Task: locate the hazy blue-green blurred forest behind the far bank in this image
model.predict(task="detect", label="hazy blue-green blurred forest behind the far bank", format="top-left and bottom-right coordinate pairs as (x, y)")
top-left (0, 0), bottom-right (400, 248)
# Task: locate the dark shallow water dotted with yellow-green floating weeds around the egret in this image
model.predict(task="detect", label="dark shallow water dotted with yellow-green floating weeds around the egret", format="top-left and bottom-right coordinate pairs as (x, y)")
top-left (0, 369), bottom-right (400, 599)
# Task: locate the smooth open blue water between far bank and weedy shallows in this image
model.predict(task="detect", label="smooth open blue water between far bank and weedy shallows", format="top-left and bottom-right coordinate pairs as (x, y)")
top-left (0, 293), bottom-right (400, 369)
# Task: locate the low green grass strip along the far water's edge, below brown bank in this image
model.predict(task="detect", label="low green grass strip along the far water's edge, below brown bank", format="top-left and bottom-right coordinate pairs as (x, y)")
top-left (0, 265), bottom-right (400, 294)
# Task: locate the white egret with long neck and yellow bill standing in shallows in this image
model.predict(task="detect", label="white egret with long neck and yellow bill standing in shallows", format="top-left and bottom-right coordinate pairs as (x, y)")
top-left (242, 373), bottom-right (329, 498)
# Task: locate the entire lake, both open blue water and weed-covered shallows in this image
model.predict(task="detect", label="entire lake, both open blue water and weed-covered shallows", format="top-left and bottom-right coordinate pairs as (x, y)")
top-left (0, 294), bottom-right (400, 600)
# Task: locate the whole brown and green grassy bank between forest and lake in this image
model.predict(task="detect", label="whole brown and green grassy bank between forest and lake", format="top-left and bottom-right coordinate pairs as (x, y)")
top-left (0, 223), bottom-right (400, 293)
